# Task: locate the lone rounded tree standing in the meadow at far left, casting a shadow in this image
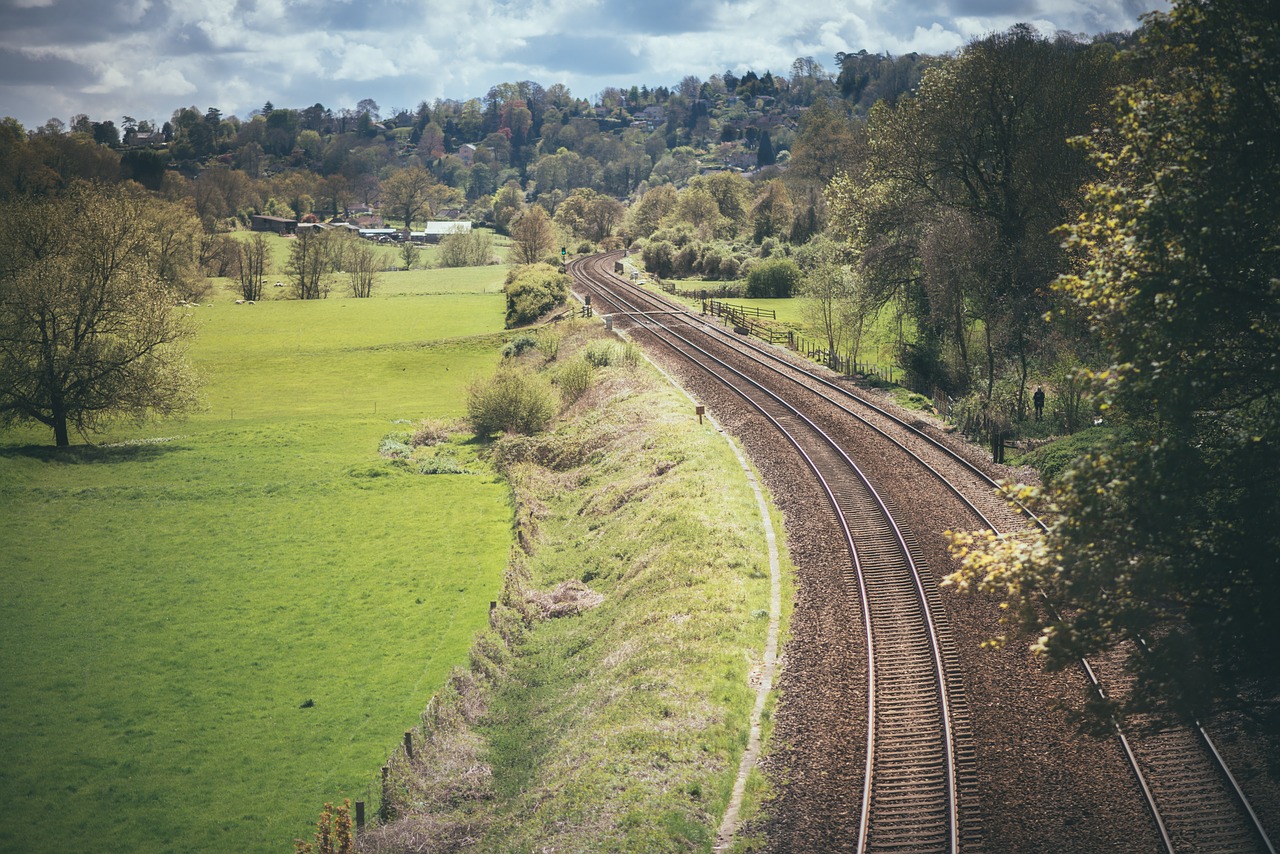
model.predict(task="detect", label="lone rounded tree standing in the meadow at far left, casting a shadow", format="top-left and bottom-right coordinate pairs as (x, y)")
top-left (0, 183), bottom-right (197, 447)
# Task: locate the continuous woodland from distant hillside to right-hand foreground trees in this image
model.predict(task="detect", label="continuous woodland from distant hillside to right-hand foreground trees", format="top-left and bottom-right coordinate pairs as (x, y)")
top-left (0, 0), bottom-right (1280, 727)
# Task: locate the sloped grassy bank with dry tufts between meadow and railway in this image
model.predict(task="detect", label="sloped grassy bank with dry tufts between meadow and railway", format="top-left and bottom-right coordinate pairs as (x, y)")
top-left (358, 325), bottom-right (788, 851)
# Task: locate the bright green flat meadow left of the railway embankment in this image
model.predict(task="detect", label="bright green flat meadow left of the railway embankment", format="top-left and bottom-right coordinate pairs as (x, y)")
top-left (0, 257), bottom-right (512, 851)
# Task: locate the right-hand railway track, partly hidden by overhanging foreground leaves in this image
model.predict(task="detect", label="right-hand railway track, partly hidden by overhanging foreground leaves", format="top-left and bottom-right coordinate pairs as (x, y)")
top-left (576, 255), bottom-right (1276, 854)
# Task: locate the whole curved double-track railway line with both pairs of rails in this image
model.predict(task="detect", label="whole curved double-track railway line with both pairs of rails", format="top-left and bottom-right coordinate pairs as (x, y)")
top-left (570, 252), bottom-right (1275, 854)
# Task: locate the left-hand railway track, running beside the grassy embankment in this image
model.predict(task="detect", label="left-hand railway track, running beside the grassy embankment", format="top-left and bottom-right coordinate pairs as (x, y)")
top-left (575, 252), bottom-right (960, 854)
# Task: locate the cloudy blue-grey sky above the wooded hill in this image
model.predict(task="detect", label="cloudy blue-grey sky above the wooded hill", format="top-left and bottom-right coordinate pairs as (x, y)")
top-left (0, 0), bottom-right (1167, 128)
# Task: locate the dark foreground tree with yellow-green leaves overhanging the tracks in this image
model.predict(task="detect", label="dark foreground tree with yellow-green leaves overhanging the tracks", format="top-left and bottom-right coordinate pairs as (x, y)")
top-left (956, 0), bottom-right (1280, 729)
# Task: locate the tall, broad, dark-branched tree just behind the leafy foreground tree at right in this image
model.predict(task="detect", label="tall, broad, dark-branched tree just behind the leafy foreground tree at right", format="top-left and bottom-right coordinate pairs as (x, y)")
top-left (834, 24), bottom-right (1116, 401)
